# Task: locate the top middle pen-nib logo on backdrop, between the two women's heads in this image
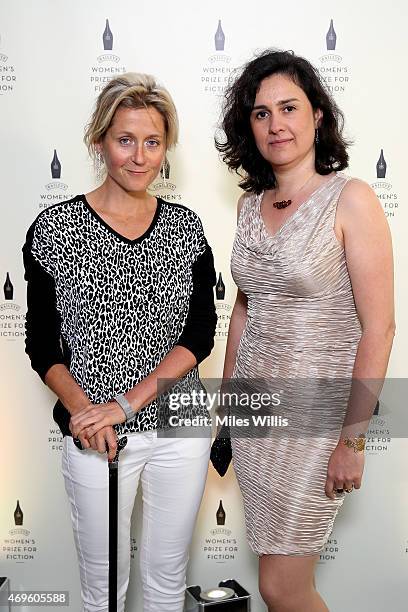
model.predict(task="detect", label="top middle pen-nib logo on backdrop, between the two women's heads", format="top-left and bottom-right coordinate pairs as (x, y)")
top-left (201, 19), bottom-right (232, 96)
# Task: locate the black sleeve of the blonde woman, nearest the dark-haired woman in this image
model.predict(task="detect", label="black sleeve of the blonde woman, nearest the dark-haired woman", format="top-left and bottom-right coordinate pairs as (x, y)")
top-left (177, 242), bottom-right (217, 363)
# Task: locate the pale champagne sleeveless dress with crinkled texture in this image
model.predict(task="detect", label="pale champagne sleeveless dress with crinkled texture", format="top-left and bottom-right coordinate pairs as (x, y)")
top-left (231, 173), bottom-right (361, 555)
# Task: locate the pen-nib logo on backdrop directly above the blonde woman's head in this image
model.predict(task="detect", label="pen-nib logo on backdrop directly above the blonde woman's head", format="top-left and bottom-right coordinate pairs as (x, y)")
top-left (90, 19), bottom-right (126, 92)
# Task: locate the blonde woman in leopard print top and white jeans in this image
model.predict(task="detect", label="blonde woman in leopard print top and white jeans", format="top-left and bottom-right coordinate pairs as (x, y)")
top-left (23, 74), bottom-right (216, 612)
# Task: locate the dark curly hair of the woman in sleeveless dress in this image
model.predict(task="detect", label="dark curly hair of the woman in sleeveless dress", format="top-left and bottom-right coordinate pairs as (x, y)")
top-left (215, 49), bottom-right (350, 193)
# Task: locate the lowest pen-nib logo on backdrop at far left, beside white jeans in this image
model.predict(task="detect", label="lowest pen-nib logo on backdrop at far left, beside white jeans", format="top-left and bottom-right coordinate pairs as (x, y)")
top-left (1, 499), bottom-right (38, 563)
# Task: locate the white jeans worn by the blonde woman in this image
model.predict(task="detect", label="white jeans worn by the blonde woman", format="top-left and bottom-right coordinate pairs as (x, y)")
top-left (62, 428), bottom-right (211, 612)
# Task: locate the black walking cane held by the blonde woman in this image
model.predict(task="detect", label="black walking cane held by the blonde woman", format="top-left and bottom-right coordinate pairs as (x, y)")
top-left (74, 436), bottom-right (127, 612)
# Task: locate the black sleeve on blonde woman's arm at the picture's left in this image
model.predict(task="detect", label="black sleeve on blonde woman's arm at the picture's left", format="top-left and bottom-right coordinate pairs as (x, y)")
top-left (23, 224), bottom-right (65, 381)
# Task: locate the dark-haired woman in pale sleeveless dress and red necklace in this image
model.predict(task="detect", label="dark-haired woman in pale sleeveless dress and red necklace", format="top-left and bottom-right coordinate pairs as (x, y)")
top-left (217, 51), bottom-right (394, 612)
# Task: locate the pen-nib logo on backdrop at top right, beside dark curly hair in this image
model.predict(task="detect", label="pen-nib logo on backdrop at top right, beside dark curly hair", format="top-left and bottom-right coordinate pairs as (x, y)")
top-left (318, 19), bottom-right (351, 94)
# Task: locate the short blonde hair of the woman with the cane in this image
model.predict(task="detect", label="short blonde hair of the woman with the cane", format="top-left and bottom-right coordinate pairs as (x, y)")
top-left (84, 72), bottom-right (178, 159)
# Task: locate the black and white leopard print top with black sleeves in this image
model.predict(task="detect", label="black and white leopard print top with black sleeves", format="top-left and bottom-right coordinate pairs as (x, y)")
top-left (23, 195), bottom-right (216, 435)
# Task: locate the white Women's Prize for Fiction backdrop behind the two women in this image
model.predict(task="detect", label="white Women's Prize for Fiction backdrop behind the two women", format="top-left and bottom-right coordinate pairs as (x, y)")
top-left (0, 0), bottom-right (408, 612)
